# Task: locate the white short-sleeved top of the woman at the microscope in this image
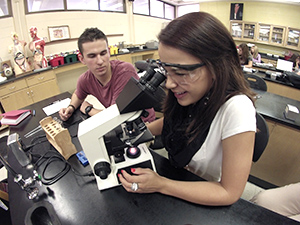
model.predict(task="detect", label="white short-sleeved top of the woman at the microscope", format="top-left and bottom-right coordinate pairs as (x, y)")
top-left (186, 95), bottom-right (256, 181)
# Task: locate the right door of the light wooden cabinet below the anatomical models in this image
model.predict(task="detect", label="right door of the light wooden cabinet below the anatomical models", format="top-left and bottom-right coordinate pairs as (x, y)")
top-left (29, 79), bottom-right (60, 102)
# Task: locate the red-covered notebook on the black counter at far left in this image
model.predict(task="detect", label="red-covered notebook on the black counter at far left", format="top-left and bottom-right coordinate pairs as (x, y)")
top-left (0, 109), bottom-right (31, 126)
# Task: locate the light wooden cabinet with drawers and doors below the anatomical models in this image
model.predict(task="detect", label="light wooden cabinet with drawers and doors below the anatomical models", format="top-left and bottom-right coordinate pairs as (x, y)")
top-left (0, 70), bottom-right (60, 111)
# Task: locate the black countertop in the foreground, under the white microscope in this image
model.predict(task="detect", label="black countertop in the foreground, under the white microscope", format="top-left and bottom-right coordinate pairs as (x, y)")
top-left (8, 93), bottom-right (299, 225)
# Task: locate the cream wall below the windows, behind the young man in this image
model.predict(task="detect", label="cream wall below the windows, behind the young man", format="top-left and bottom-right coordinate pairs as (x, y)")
top-left (0, 0), bottom-right (169, 67)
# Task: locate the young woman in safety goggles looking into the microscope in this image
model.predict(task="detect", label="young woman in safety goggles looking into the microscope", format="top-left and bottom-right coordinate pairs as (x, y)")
top-left (119, 12), bottom-right (256, 205)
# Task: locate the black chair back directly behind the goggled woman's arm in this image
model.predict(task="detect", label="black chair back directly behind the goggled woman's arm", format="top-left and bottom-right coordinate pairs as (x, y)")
top-left (252, 112), bottom-right (269, 162)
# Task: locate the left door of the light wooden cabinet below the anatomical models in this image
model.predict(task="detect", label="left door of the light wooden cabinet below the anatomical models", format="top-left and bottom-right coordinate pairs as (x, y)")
top-left (0, 88), bottom-right (33, 112)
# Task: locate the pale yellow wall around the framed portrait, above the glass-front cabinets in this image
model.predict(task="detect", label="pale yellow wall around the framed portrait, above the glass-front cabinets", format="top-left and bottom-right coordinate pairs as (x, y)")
top-left (200, 1), bottom-right (300, 55)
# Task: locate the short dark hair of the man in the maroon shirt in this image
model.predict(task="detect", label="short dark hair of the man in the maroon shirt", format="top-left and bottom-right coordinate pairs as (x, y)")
top-left (77, 28), bottom-right (108, 54)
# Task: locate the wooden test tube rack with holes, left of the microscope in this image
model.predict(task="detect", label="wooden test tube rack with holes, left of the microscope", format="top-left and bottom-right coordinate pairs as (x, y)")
top-left (40, 116), bottom-right (77, 160)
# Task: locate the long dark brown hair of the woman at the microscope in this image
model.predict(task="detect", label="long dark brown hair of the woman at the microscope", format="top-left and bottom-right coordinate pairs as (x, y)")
top-left (158, 12), bottom-right (255, 142)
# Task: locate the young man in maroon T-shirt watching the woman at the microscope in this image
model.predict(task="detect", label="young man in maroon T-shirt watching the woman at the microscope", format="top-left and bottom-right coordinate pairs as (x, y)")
top-left (59, 28), bottom-right (155, 122)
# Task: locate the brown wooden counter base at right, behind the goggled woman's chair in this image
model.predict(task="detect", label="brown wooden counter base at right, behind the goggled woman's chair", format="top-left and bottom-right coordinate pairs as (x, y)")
top-left (251, 120), bottom-right (300, 186)
